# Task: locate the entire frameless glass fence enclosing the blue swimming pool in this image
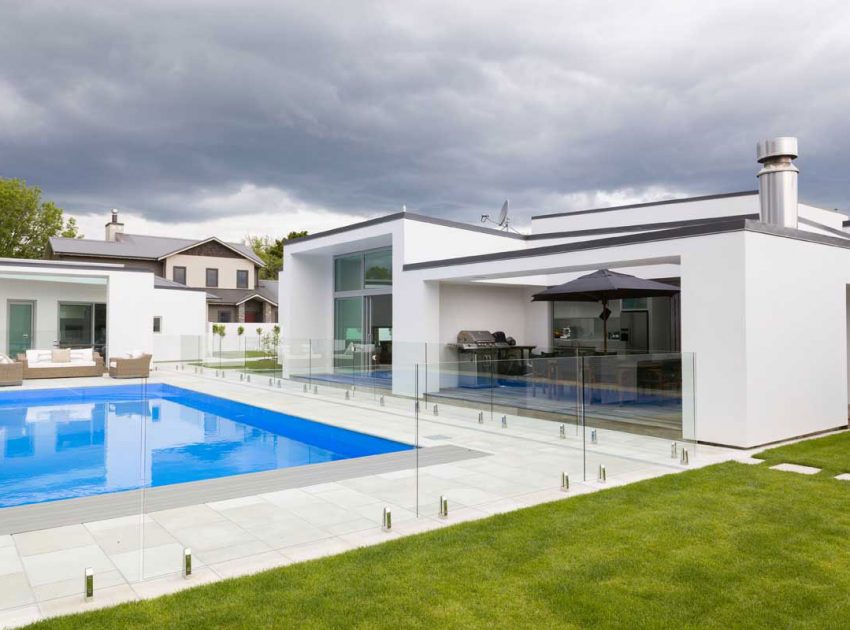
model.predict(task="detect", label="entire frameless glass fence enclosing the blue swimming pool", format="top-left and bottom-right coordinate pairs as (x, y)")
top-left (0, 344), bottom-right (700, 621)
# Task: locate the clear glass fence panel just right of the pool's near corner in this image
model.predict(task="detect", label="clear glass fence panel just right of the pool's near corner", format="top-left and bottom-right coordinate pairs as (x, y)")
top-left (412, 358), bottom-right (584, 525)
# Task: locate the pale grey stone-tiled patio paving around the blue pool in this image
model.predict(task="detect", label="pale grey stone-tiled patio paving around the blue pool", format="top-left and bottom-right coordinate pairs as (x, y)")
top-left (0, 369), bottom-right (748, 626)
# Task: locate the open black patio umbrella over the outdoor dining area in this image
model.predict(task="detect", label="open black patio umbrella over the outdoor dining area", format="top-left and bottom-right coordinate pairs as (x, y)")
top-left (531, 269), bottom-right (679, 352)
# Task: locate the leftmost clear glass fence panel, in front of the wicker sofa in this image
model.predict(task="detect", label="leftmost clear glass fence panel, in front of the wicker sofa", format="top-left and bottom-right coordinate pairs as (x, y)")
top-left (0, 372), bottom-right (151, 615)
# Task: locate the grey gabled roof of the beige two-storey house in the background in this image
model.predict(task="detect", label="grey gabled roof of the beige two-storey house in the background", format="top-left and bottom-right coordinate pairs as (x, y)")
top-left (50, 233), bottom-right (265, 267)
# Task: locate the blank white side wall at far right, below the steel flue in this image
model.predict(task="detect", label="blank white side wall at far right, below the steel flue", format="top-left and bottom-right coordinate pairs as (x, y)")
top-left (744, 233), bottom-right (850, 444)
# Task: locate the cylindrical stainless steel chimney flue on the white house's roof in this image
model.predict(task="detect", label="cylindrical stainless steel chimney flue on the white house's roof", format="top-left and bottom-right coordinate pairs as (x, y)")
top-left (756, 137), bottom-right (800, 229)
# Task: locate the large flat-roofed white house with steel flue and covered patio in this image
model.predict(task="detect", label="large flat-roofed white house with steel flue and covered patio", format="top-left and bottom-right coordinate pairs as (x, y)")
top-left (279, 138), bottom-right (850, 447)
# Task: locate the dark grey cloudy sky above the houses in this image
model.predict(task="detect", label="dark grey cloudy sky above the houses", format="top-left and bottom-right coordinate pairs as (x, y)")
top-left (0, 0), bottom-right (850, 239)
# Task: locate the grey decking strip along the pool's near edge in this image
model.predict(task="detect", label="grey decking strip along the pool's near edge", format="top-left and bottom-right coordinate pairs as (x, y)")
top-left (0, 444), bottom-right (489, 535)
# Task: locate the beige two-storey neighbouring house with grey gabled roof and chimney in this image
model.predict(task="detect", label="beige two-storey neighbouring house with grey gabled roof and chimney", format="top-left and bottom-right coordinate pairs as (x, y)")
top-left (49, 210), bottom-right (278, 323)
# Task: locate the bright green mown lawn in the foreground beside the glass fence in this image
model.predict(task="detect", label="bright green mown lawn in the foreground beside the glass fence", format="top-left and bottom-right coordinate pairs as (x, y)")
top-left (26, 463), bottom-right (850, 630)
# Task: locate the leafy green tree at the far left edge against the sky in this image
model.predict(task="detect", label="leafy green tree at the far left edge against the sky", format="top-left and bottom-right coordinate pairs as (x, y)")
top-left (0, 178), bottom-right (82, 258)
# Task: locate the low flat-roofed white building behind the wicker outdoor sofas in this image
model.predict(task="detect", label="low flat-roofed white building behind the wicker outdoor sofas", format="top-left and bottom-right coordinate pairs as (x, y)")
top-left (0, 258), bottom-right (207, 361)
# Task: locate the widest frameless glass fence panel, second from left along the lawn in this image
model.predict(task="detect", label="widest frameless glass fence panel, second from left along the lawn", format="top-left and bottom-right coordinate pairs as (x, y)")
top-left (137, 346), bottom-right (419, 591)
